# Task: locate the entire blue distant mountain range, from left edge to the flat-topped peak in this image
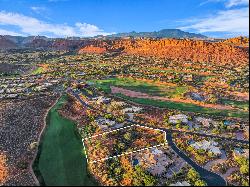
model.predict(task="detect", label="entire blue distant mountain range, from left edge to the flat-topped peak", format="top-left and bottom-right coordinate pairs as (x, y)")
top-left (0, 29), bottom-right (207, 50)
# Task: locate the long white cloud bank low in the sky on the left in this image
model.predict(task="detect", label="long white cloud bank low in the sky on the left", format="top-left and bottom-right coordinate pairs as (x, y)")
top-left (0, 11), bottom-right (114, 37)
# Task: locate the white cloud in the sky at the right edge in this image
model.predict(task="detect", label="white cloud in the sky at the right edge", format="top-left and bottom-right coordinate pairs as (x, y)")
top-left (180, 8), bottom-right (249, 35)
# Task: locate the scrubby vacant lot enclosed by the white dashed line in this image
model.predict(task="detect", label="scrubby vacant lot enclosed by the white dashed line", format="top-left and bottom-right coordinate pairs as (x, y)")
top-left (85, 126), bottom-right (165, 161)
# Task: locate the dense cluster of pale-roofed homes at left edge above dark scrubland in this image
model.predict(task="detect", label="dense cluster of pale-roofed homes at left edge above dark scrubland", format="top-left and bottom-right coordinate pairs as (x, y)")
top-left (0, 75), bottom-right (60, 99)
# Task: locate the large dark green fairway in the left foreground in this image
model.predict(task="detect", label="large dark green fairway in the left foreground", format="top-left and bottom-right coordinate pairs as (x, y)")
top-left (35, 96), bottom-right (96, 186)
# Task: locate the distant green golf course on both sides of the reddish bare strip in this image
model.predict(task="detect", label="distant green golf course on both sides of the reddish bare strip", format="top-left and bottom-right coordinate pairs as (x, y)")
top-left (89, 78), bottom-right (248, 118)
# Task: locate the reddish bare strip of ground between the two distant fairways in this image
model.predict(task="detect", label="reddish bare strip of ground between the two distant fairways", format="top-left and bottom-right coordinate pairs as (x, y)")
top-left (110, 86), bottom-right (234, 110)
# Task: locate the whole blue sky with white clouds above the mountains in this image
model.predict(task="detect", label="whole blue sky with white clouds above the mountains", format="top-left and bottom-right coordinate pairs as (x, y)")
top-left (0, 0), bottom-right (249, 38)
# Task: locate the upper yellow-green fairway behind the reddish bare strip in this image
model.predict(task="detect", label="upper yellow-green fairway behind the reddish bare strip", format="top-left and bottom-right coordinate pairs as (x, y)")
top-left (90, 78), bottom-right (188, 97)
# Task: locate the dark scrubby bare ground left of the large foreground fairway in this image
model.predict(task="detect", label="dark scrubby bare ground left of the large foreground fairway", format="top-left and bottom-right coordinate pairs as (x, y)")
top-left (0, 96), bottom-right (58, 186)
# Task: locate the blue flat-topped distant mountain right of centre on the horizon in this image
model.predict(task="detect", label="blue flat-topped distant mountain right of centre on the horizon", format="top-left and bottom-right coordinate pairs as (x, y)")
top-left (107, 29), bottom-right (208, 39)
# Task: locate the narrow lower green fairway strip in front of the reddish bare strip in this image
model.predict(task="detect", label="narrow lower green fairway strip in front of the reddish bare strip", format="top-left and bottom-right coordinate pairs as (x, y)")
top-left (116, 94), bottom-right (249, 118)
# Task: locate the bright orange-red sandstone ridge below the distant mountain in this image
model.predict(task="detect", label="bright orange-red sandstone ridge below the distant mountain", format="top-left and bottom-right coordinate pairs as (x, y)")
top-left (77, 39), bottom-right (248, 65)
